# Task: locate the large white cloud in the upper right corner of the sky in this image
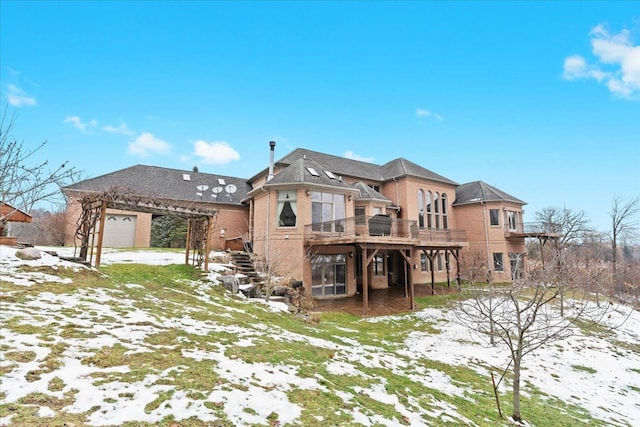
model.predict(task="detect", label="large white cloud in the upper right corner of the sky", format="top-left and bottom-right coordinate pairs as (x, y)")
top-left (563, 25), bottom-right (640, 99)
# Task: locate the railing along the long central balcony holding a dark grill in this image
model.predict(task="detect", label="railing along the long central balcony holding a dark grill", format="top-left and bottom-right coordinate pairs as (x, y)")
top-left (304, 215), bottom-right (467, 243)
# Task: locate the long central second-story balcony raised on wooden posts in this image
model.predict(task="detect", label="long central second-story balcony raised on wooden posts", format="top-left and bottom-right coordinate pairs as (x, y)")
top-left (304, 215), bottom-right (467, 247)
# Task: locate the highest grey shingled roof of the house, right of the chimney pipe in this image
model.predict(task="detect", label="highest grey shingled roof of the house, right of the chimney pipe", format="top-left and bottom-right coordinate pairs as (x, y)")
top-left (249, 148), bottom-right (458, 185)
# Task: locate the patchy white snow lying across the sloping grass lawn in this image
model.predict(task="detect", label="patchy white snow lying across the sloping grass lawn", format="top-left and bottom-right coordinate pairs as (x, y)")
top-left (0, 246), bottom-right (640, 426)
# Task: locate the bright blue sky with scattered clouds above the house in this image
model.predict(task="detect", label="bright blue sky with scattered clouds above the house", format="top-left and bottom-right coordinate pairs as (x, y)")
top-left (0, 0), bottom-right (640, 231)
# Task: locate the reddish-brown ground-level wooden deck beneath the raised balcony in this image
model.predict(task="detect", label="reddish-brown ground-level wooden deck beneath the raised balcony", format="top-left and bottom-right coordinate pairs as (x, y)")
top-left (314, 284), bottom-right (457, 317)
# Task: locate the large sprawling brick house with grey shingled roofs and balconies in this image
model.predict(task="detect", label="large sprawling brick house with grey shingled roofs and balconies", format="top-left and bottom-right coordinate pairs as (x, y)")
top-left (63, 142), bottom-right (527, 310)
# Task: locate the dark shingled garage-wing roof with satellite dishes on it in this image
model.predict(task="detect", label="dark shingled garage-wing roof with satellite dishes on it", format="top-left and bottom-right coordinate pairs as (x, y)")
top-left (62, 165), bottom-right (251, 205)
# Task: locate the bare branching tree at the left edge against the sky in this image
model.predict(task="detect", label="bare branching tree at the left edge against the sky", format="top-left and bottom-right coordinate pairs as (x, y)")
top-left (0, 109), bottom-right (80, 221)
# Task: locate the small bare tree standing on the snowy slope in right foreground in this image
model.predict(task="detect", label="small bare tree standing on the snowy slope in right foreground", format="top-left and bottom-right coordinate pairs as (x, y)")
top-left (455, 253), bottom-right (611, 422)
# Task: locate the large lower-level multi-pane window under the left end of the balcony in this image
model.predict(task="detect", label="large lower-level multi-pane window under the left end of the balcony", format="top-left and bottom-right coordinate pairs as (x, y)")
top-left (311, 254), bottom-right (347, 296)
